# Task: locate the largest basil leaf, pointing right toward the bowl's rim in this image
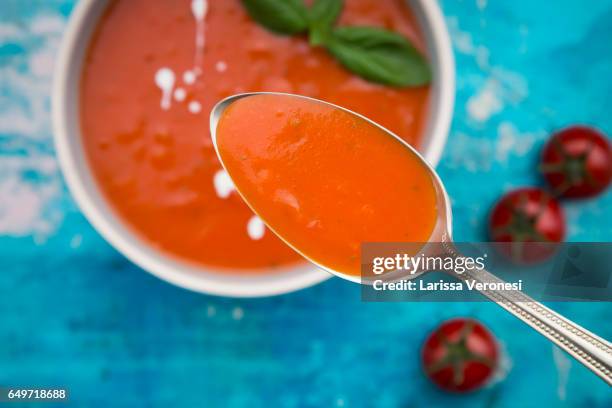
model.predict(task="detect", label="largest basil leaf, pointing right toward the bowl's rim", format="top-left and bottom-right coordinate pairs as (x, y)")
top-left (327, 27), bottom-right (431, 86)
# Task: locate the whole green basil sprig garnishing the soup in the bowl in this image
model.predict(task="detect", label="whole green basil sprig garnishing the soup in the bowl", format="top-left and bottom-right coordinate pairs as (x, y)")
top-left (242, 0), bottom-right (431, 86)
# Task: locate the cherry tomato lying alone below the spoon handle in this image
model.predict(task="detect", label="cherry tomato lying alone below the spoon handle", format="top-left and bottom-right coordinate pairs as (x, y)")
top-left (422, 318), bottom-right (499, 392)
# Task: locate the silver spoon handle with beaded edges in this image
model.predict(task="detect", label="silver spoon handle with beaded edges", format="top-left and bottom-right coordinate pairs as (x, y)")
top-left (460, 269), bottom-right (612, 385)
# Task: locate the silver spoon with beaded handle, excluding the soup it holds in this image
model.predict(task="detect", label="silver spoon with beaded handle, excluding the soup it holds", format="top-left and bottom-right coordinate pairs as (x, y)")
top-left (210, 92), bottom-right (612, 385)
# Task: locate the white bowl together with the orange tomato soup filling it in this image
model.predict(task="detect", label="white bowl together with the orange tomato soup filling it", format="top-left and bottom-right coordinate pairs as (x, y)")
top-left (53, 0), bottom-right (454, 296)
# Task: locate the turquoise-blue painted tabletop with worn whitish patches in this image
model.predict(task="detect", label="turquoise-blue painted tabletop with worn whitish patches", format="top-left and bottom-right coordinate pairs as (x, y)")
top-left (0, 0), bottom-right (612, 408)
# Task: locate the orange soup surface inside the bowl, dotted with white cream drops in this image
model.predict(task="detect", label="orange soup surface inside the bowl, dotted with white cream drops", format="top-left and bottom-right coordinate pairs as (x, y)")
top-left (80, 0), bottom-right (429, 273)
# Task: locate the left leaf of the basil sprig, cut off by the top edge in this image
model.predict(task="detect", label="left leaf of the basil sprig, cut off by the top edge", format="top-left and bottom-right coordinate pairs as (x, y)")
top-left (242, 0), bottom-right (308, 34)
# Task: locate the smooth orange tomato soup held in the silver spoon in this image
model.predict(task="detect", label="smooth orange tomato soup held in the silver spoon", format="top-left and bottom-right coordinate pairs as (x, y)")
top-left (217, 95), bottom-right (437, 275)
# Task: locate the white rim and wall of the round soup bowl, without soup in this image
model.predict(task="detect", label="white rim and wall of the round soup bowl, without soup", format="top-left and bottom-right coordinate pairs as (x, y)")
top-left (52, 0), bottom-right (455, 297)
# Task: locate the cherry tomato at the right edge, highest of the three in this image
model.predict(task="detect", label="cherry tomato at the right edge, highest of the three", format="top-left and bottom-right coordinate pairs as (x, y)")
top-left (540, 126), bottom-right (612, 198)
